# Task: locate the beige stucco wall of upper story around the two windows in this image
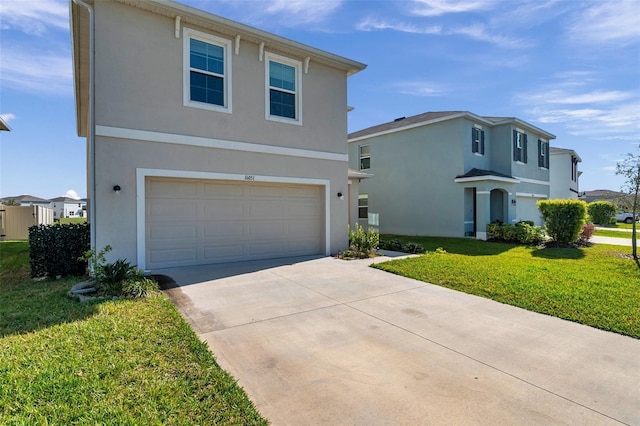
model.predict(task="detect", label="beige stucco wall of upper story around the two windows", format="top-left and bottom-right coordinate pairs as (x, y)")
top-left (95, 2), bottom-right (347, 153)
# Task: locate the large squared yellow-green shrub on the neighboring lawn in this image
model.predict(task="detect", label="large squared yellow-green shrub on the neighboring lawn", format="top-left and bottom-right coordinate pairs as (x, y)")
top-left (538, 200), bottom-right (587, 244)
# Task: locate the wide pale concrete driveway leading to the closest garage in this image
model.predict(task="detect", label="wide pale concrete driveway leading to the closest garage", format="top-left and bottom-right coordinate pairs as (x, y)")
top-left (163, 258), bottom-right (640, 425)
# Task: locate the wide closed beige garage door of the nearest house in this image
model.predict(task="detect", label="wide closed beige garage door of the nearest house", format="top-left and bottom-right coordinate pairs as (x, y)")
top-left (145, 178), bottom-right (324, 268)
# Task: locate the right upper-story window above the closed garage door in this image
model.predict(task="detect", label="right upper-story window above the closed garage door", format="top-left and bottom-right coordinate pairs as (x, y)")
top-left (265, 52), bottom-right (302, 124)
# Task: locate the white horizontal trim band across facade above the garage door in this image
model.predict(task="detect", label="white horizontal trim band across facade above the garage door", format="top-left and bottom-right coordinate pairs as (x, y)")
top-left (96, 125), bottom-right (349, 162)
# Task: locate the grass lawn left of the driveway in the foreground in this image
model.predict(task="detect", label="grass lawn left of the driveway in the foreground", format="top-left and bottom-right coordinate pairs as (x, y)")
top-left (0, 242), bottom-right (267, 425)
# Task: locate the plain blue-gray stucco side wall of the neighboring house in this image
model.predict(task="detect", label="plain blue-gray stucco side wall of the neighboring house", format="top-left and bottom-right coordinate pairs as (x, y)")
top-left (351, 120), bottom-right (467, 236)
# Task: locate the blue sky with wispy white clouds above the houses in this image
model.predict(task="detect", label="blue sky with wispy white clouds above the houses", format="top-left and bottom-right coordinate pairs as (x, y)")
top-left (0, 0), bottom-right (640, 198)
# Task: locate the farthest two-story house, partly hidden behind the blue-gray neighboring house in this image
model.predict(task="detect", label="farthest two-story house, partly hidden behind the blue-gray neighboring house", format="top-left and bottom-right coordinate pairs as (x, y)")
top-left (549, 147), bottom-right (582, 199)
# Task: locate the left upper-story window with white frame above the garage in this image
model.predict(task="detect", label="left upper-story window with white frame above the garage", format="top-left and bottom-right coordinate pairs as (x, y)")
top-left (183, 28), bottom-right (231, 112)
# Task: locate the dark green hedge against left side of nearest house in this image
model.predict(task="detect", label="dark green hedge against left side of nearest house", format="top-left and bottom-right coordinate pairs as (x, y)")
top-left (29, 223), bottom-right (91, 278)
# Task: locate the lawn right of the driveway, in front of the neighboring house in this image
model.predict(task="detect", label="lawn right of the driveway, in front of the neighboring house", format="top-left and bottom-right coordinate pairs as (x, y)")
top-left (373, 236), bottom-right (640, 338)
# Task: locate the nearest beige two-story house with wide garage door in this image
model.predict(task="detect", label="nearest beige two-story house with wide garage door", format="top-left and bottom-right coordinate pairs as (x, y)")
top-left (70, 0), bottom-right (365, 270)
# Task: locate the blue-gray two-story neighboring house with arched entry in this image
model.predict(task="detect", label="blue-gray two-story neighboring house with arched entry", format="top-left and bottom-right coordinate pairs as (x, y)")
top-left (349, 111), bottom-right (555, 239)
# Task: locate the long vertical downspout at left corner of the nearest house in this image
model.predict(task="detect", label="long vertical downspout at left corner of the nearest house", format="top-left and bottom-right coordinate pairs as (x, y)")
top-left (69, 0), bottom-right (96, 253)
